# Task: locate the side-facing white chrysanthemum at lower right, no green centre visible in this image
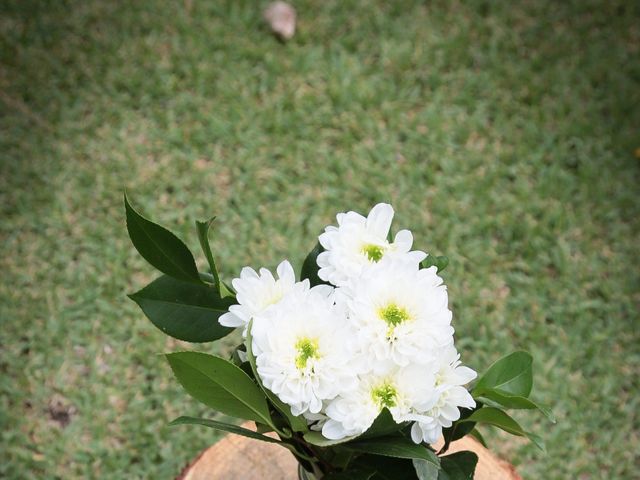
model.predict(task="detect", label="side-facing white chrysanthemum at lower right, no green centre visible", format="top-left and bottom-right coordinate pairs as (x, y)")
top-left (411, 345), bottom-right (477, 443)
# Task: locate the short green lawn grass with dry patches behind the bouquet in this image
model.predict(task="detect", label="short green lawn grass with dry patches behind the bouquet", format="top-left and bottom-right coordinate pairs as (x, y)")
top-left (0, 0), bottom-right (640, 479)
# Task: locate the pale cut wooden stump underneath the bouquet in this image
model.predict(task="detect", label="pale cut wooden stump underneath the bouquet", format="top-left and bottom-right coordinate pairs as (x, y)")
top-left (178, 424), bottom-right (522, 480)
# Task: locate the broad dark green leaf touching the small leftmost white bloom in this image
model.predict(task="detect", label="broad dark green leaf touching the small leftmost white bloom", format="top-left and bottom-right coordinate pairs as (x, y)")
top-left (129, 275), bottom-right (235, 342)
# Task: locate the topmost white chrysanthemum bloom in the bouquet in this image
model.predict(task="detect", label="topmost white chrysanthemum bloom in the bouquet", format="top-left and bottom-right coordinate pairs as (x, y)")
top-left (317, 203), bottom-right (426, 286)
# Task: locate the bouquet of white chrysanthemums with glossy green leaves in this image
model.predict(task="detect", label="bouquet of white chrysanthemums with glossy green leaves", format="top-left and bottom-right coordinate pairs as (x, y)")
top-left (125, 195), bottom-right (554, 480)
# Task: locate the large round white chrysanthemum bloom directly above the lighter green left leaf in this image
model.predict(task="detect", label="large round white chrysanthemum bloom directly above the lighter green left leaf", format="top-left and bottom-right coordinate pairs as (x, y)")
top-left (251, 280), bottom-right (358, 415)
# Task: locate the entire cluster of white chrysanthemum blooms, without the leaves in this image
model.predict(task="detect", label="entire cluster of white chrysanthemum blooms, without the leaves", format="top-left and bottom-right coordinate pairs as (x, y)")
top-left (219, 203), bottom-right (476, 443)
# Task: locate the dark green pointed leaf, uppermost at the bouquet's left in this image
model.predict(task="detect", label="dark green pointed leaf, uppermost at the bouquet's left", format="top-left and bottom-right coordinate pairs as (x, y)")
top-left (124, 193), bottom-right (200, 283)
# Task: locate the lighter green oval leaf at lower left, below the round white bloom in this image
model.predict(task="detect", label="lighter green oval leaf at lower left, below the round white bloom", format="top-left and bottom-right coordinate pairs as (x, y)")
top-left (167, 352), bottom-right (273, 426)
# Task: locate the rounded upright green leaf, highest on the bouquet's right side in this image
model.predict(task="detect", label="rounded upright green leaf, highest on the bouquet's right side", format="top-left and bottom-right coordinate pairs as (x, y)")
top-left (473, 351), bottom-right (533, 397)
